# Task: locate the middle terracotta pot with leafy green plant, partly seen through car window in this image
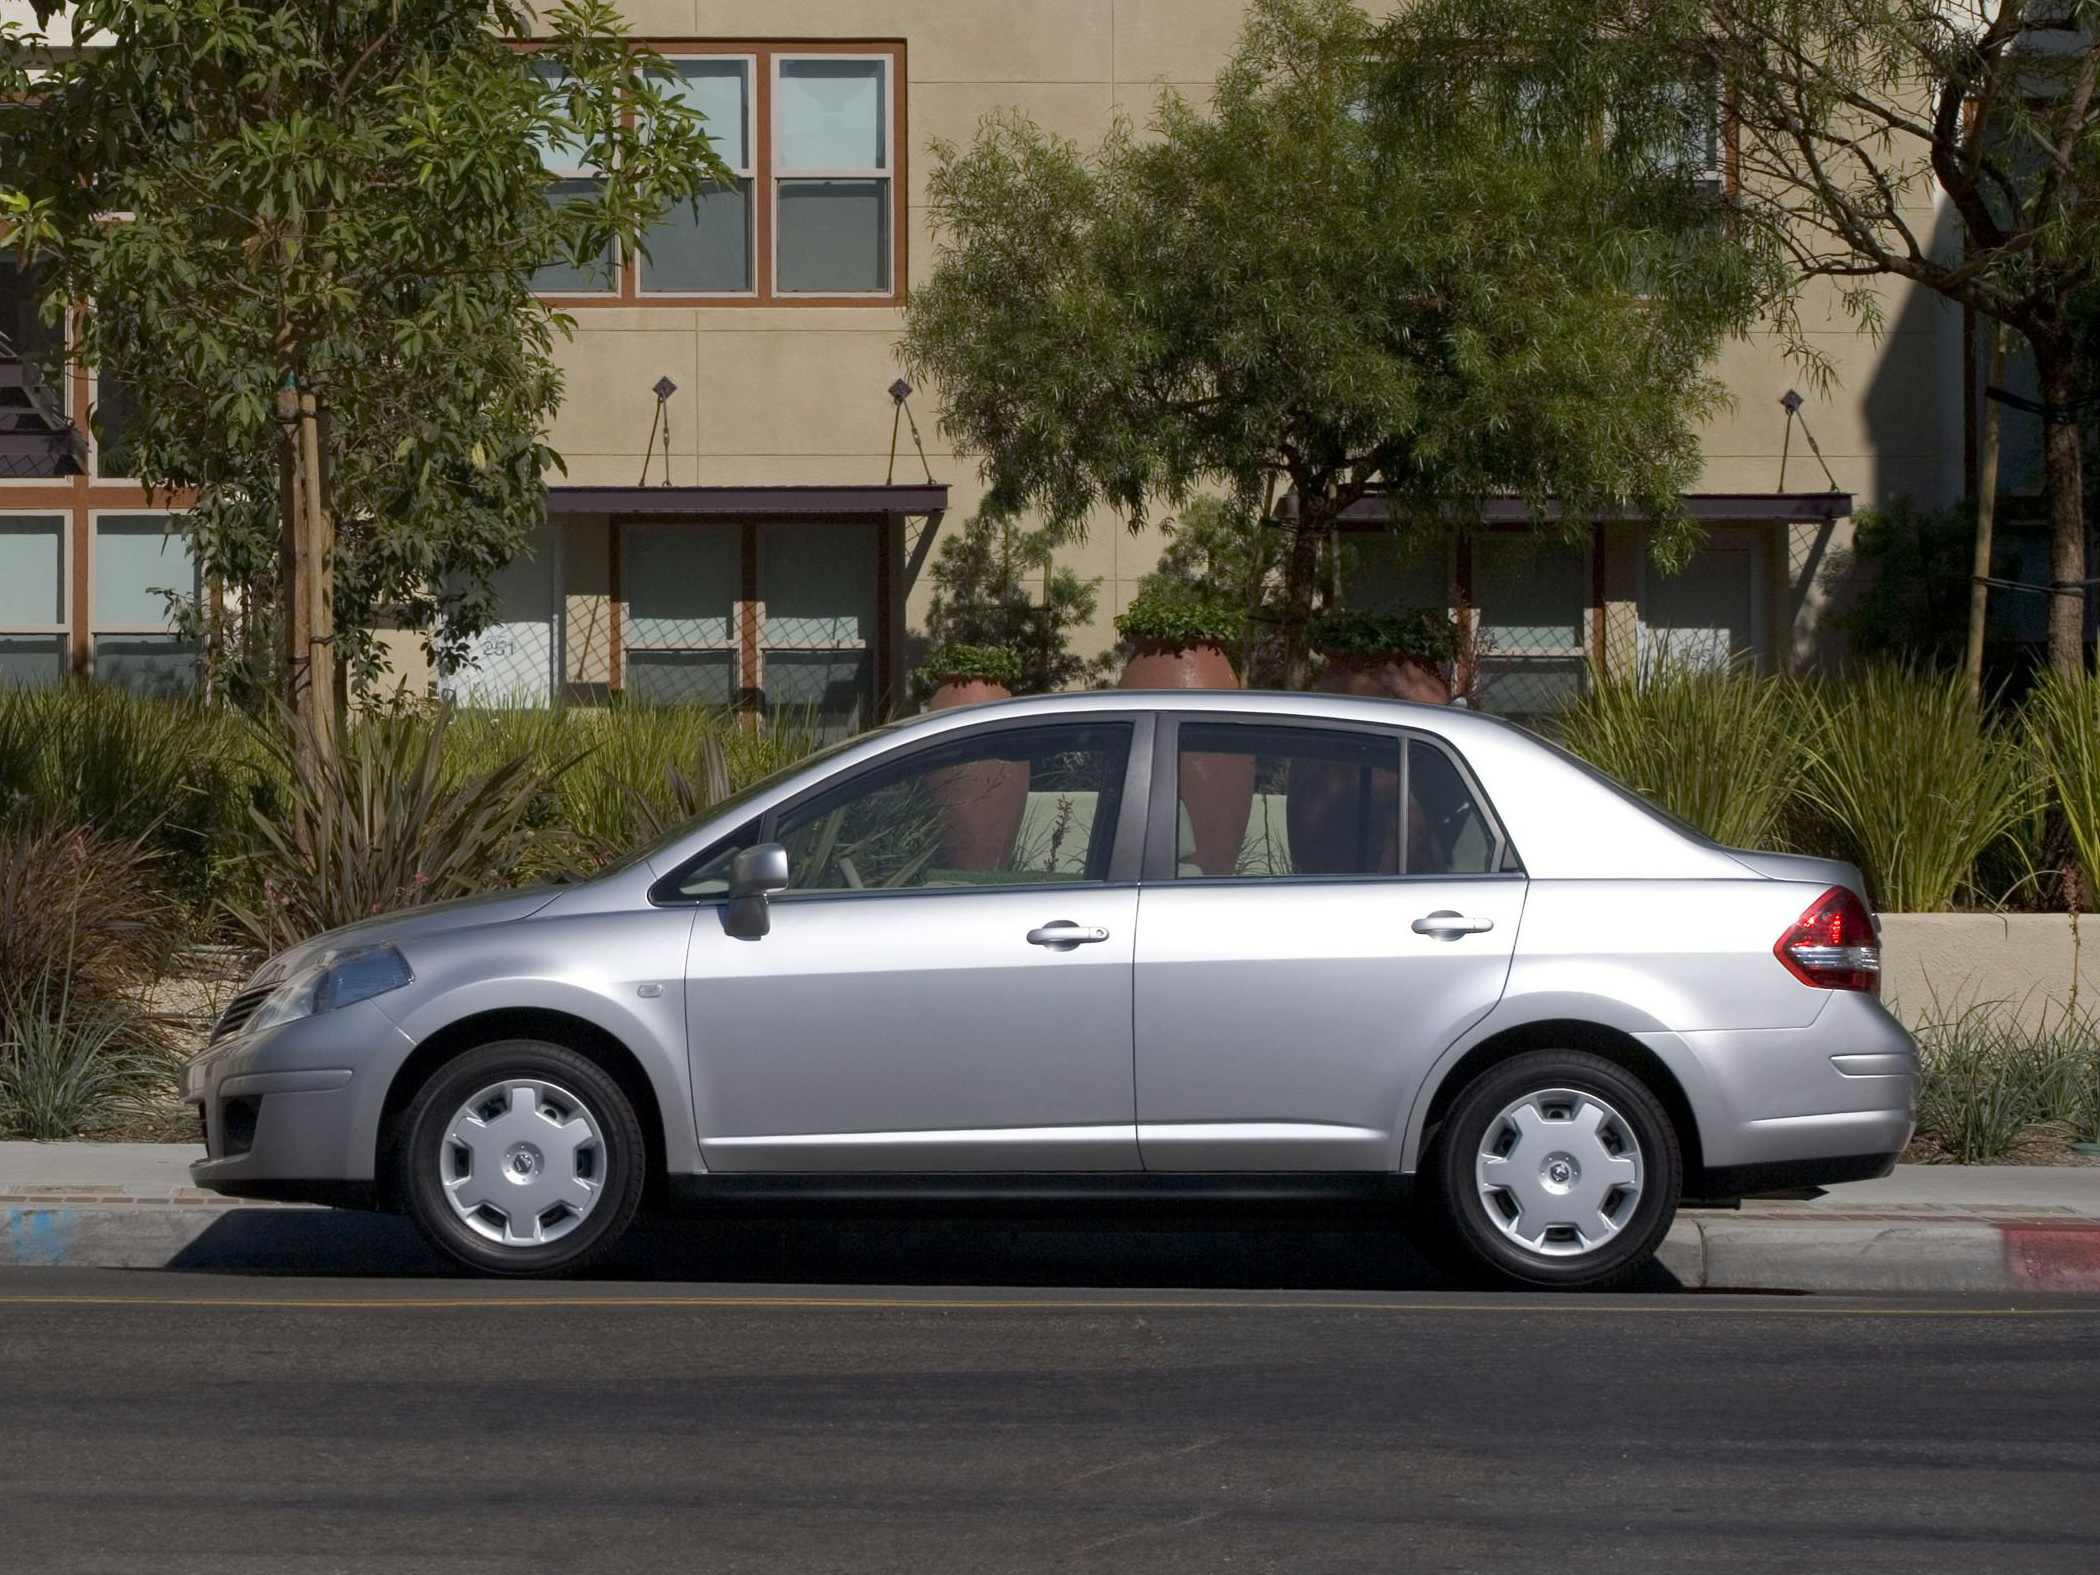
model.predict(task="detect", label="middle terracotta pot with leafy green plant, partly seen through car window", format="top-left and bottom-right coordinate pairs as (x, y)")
top-left (1115, 584), bottom-right (1254, 876)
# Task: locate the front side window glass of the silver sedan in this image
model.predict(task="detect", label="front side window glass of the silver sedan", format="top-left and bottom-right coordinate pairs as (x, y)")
top-left (773, 722), bottom-right (1132, 893)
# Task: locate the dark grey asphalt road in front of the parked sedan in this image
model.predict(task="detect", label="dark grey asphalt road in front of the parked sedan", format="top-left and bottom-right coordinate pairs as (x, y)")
top-left (0, 1268), bottom-right (2100, 1575)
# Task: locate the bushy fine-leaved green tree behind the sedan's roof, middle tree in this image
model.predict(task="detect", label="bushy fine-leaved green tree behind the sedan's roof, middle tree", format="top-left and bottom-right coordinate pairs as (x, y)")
top-left (903, 0), bottom-right (1756, 685)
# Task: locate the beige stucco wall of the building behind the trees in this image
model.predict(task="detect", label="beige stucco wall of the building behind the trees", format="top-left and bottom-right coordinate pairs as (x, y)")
top-left (529, 0), bottom-right (1961, 678)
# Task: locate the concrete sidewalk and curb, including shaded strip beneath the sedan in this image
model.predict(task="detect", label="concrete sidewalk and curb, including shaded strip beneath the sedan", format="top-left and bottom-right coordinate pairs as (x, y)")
top-left (12, 1142), bottom-right (2100, 1294)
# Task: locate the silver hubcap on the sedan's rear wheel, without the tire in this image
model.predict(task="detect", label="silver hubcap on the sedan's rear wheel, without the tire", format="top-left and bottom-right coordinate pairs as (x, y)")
top-left (1472, 1088), bottom-right (1644, 1258)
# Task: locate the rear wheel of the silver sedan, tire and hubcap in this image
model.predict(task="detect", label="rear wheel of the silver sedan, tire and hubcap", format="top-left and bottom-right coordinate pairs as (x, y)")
top-left (1418, 1050), bottom-right (1684, 1292)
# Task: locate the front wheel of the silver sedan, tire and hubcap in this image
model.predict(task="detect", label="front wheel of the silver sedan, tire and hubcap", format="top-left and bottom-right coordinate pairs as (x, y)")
top-left (395, 1040), bottom-right (649, 1277)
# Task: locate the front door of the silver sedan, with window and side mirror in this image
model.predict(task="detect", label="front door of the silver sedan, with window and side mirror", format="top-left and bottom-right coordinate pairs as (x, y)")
top-left (685, 716), bottom-right (1151, 1172)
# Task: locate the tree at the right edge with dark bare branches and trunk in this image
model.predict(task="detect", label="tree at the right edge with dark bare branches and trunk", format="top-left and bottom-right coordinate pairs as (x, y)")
top-left (1388, 0), bottom-right (2100, 672)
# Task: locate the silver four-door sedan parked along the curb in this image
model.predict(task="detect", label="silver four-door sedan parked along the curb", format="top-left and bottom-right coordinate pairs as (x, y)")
top-left (185, 693), bottom-right (1917, 1287)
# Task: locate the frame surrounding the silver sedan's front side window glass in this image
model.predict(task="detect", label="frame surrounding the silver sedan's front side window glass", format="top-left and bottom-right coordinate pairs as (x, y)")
top-left (649, 710), bottom-right (1159, 907)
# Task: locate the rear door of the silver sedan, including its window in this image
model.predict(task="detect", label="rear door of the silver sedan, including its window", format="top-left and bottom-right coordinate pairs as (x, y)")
top-left (1136, 718), bottom-right (1525, 1172)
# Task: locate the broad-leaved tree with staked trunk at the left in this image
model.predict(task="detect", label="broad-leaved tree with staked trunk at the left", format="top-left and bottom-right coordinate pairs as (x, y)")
top-left (0, 0), bottom-right (727, 739)
